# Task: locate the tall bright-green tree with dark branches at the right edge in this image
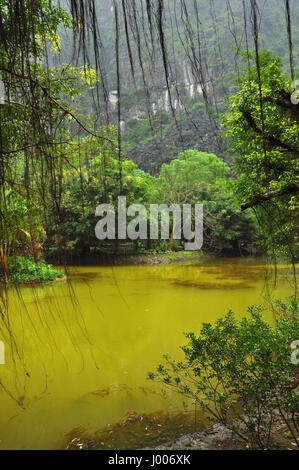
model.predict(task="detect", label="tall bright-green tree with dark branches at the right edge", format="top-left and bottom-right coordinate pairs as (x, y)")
top-left (223, 51), bottom-right (299, 261)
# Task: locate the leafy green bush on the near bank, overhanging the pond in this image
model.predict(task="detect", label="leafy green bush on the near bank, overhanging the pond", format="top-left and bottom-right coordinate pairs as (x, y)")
top-left (149, 301), bottom-right (299, 449)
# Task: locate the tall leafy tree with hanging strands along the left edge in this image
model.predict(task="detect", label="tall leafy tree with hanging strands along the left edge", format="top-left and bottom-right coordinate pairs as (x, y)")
top-left (0, 0), bottom-right (112, 276)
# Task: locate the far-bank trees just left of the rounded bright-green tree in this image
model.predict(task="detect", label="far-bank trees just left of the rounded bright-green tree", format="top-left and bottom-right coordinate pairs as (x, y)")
top-left (46, 128), bottom-right (154, 256)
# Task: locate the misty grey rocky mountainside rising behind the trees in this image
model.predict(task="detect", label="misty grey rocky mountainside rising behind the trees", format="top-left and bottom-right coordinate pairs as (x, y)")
top-left (57, 0), bottom-right (299, 174)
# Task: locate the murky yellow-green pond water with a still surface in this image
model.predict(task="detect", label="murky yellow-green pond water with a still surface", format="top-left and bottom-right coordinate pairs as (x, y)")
top-left (0, 258), bottom-right (292, 449)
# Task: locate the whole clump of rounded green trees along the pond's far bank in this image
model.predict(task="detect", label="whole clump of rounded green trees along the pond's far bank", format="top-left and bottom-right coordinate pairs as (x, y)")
top-left (42, 146), bottom-right (257, 256)
